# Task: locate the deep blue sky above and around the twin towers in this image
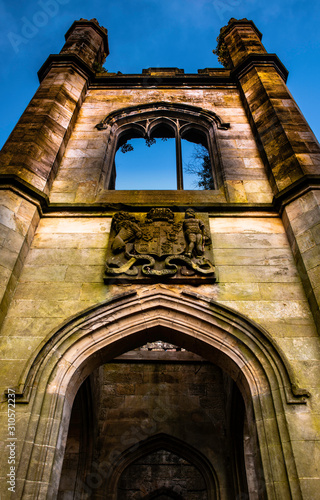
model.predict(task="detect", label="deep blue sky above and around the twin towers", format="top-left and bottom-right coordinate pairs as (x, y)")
top-left (0, 0), bottom-right (320, 147)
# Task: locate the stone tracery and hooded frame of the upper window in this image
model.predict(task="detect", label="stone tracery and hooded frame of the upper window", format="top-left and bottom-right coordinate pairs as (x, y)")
top-left (96, 102), bottom-right (230, 189)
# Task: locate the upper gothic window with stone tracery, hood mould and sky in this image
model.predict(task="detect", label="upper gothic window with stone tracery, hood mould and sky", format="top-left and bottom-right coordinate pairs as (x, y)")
top-left (97, 103), bottom-right (229, 190)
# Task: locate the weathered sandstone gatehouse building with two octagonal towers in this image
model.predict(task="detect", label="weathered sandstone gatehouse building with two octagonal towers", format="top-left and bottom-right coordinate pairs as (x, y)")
top-left (0, 19), bottom-right (320, 500)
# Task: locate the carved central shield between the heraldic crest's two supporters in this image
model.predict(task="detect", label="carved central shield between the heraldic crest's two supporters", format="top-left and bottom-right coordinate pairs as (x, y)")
top-left (134, 221), bottom-right (186, 257)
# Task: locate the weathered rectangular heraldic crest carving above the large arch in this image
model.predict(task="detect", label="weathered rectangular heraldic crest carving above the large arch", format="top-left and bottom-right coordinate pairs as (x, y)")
top-left (105, 208), bottom-right (215, 284)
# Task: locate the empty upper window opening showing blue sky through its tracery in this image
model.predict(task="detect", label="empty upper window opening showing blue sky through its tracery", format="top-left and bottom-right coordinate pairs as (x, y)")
top-left (109, 122), bottom-right (215, 190)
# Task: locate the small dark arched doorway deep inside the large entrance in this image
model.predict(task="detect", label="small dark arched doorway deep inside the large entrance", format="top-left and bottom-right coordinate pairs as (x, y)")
top-left (115, 434), bottom-right (218, 500)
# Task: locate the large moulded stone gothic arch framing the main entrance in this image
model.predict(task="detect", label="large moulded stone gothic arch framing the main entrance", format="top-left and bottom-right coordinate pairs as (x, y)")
top-left (13, 285), bottom-right (306, 499)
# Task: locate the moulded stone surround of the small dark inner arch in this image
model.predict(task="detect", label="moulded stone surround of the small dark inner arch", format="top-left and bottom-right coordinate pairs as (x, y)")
top-left (106, 433), bottom-right (220, 500)
